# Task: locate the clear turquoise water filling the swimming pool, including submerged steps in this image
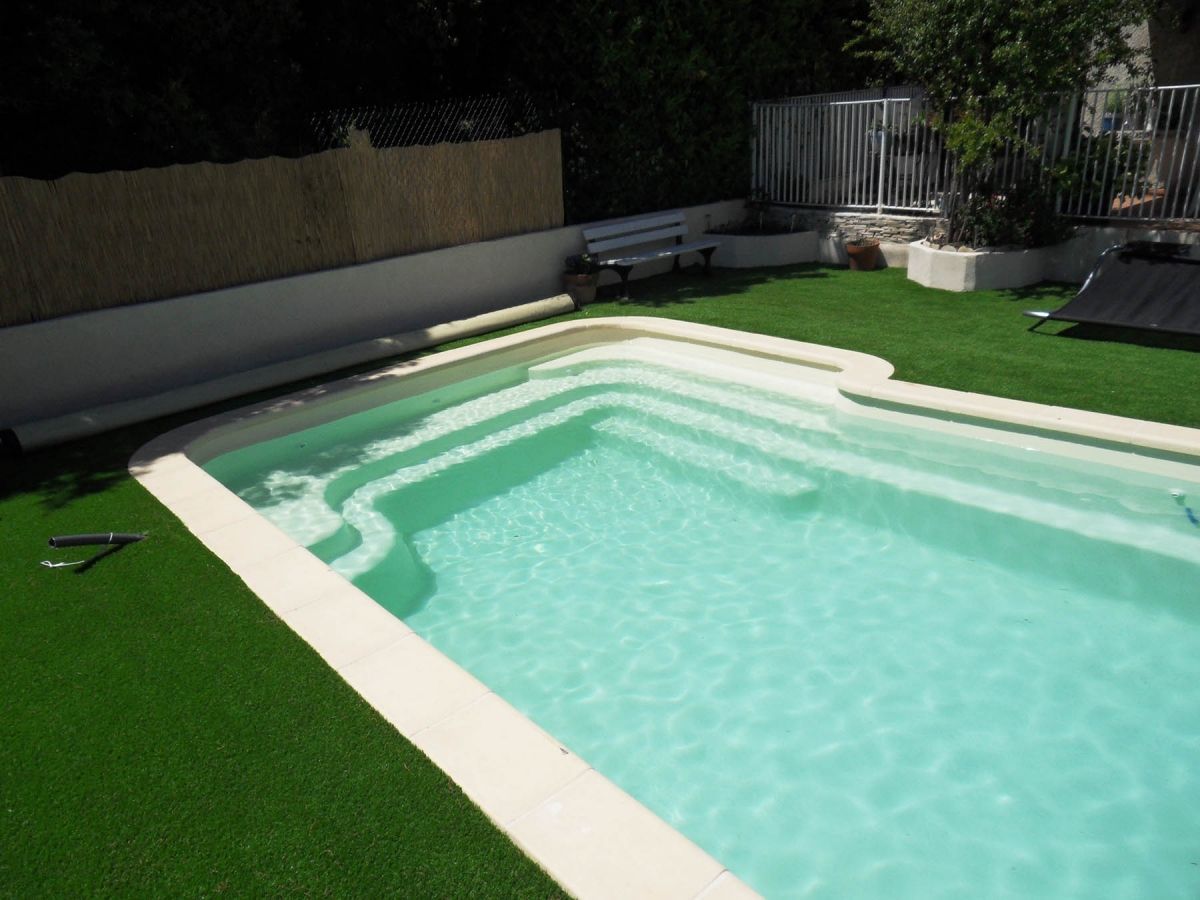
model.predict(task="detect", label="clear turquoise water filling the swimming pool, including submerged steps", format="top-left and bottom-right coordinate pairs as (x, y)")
top-left (205, 340), bottom-right (1200, 898)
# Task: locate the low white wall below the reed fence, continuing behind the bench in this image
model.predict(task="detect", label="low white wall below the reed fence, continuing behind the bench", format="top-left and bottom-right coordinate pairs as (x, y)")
top-left (0, 200), bottom-right (742, 448)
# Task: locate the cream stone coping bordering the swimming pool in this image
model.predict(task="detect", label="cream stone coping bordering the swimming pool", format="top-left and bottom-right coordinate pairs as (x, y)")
top-left (130, 317), bottom-right (1200, 899)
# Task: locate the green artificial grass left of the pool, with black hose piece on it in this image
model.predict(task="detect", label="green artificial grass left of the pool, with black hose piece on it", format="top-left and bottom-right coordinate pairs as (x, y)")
top-left (0, 420), bottom-right (571, 898)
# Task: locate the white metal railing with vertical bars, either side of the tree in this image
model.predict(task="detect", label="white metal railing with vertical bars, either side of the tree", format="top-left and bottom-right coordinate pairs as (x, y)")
top-left (751, 85), bottom-right (1200, 221)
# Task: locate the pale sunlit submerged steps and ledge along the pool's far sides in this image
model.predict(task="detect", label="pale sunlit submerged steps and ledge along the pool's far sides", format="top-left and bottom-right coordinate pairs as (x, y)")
top-left (256, 348), bottom-right (1196, 577)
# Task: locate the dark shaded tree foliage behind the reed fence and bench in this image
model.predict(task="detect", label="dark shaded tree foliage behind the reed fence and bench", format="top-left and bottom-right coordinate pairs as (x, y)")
top-left (0, 0), bottom-right (872, 221)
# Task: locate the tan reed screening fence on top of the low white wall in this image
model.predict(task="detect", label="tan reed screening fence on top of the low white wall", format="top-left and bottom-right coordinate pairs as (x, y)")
top-left (0, 130), bottom-right (563, 326)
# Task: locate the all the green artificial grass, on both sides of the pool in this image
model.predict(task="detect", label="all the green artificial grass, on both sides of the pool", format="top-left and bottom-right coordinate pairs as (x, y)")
top-left (0, 266), bottom-right (1200, 898)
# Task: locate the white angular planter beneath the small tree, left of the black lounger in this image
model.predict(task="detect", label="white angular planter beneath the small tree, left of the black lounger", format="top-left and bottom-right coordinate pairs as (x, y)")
top-left (908, 241), bottom-right (1058, 290)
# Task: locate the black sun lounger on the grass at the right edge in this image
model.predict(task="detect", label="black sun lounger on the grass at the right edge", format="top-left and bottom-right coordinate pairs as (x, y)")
top-left (1025, 242), bottom-right (1200, 335)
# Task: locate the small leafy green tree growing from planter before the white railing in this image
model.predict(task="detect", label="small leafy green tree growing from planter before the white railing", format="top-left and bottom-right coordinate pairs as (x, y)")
top-left (852, 0), bottom-right (1158, 242)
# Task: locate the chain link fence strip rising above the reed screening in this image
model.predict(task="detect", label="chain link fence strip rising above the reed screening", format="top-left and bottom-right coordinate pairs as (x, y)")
top-left (310, 95), bottom-right (553, 150)
